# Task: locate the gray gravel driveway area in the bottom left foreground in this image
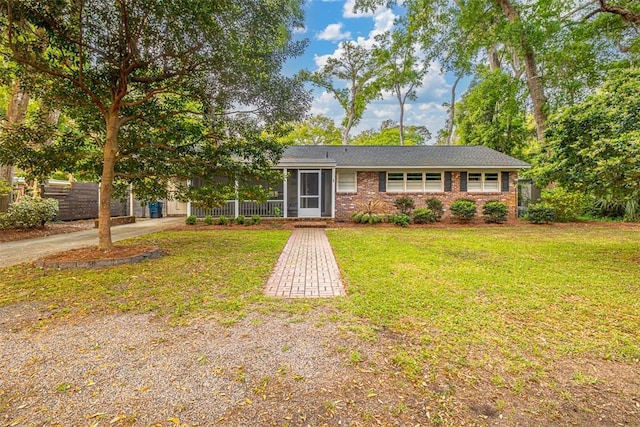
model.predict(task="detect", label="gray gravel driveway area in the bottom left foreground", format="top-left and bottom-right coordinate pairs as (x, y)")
top-left (0, 304), bottom-right (376, 426)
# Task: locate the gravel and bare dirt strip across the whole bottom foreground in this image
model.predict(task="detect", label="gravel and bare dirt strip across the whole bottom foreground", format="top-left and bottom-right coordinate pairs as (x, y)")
top-left (0, 303), bottom-right (640, 427)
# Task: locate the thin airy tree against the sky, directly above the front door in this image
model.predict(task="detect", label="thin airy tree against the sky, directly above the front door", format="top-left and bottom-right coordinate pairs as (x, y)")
top-left (302, 41), bottom-right (380, 145)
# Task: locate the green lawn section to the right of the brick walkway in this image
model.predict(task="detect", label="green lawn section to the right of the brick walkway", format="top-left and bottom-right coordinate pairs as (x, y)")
top-left (328, 226), bottom-right (640, 374)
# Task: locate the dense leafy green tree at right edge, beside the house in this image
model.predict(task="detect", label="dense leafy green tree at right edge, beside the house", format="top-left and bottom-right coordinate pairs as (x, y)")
top-left (538, 68), bottom-right (640, 218)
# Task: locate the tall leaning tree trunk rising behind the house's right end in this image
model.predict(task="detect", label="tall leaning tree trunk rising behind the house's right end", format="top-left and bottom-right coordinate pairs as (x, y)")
top-left (496, 0), bottom-right (547, 142)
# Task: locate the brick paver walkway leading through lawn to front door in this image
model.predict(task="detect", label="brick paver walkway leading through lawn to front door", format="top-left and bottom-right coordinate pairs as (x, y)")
top-left (265, 228), bottom-right (345, 298)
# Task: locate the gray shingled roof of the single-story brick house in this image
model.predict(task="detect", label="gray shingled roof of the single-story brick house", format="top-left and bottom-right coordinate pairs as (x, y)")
top-left (280, 145), bottom-right (530, 169)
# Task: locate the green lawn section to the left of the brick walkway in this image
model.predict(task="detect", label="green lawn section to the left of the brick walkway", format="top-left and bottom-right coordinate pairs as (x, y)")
top-left (0, 230), bottom-right (290, 321)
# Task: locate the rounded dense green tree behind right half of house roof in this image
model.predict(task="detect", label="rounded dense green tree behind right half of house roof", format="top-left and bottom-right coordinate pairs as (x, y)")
top-left (456, 70), bottom-right (528, 156)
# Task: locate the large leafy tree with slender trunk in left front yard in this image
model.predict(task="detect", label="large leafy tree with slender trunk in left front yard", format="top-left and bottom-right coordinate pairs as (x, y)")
top-left (0, 0), bottom-right (308, 249)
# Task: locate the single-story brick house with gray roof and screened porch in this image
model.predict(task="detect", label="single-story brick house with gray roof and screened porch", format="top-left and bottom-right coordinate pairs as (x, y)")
top-left (186, 145), bottom-right (530, 220)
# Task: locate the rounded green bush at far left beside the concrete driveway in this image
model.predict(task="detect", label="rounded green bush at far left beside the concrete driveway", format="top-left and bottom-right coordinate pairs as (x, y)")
top-left (0, 196), bottom-right (58, 228)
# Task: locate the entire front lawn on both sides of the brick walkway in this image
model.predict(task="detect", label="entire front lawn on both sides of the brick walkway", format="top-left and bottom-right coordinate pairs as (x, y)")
top-left (0, 225), bottom-right (640, 425)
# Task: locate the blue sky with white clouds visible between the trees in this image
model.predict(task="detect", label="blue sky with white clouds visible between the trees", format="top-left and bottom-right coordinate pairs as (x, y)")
top-left (286, 0), bottom-right (461, 144)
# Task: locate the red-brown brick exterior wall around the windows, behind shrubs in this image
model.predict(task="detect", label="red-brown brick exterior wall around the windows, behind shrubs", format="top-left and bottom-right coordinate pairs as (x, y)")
top-left (336, 171), bottom-right (518, 221)
